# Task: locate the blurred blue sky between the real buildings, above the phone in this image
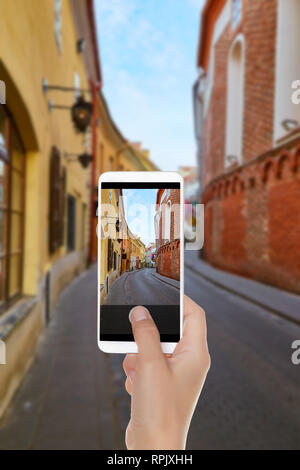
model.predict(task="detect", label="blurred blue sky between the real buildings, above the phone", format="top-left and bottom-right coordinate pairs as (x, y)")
top-left (95, 0), bottom-right (203, 170)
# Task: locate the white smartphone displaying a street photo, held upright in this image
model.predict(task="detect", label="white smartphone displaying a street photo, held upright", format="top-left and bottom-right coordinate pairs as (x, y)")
top-left (97, 171), bottom-right (184, 354)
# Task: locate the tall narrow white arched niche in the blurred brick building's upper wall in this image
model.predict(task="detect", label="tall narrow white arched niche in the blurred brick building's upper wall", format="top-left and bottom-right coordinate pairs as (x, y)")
top-left (225, 35), bottom-right (245, 166)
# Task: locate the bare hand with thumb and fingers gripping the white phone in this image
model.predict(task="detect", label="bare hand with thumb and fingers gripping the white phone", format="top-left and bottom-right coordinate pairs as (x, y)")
top-left (123, 296), bottom-right (210, 450)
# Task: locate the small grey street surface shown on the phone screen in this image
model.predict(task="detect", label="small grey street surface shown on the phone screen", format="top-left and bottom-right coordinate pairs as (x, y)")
top-left (104, 268), bottom-right (179, 305)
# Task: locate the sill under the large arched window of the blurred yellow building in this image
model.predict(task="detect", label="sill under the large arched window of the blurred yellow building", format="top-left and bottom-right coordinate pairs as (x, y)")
top-left (0, 297), bottom-right (37, 340)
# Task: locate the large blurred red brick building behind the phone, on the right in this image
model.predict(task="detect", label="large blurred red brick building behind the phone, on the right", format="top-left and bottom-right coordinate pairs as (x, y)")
top-left (194, 0), bottom-right (300, 293)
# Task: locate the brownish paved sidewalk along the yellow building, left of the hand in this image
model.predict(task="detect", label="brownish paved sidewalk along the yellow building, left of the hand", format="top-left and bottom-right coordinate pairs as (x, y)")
top-left (0, 266), bottom-right (129, 449)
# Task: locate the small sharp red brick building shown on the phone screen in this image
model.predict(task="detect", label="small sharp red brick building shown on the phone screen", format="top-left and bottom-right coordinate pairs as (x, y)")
top-left (155, 189), bottom-right (180, 280)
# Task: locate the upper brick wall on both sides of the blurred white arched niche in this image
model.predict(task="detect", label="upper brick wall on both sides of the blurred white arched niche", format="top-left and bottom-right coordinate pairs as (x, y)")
top-left (203, 0), bottom-right (277, 186)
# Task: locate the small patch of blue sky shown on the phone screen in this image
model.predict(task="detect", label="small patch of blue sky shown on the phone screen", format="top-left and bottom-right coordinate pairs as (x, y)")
top-left (123, 189), bottom-right (157, 246)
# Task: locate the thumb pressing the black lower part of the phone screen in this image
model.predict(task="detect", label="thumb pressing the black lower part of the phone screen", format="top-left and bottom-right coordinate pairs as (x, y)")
top-left (129, 306), bottom-right (164, 361)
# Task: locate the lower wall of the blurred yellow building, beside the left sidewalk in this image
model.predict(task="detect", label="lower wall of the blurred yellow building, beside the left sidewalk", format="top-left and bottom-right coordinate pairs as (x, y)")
top-left (0, 252), bottom-right (86, 418)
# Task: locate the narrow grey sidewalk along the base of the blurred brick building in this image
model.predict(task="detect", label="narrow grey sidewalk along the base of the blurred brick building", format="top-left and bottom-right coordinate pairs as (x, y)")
top-left (184, 250), bottom-right (300, 325)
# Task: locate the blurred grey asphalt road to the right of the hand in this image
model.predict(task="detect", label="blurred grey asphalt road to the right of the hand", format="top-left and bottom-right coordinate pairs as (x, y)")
top-left (185, 262), bottom-right (300, 449)
